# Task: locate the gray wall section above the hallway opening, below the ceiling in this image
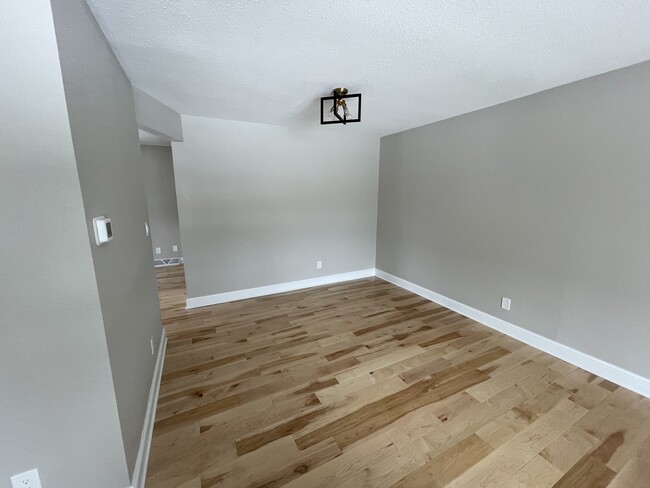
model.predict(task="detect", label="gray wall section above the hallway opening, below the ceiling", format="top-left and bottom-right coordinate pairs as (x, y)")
top-left (133, 86), bottom-right (183, 141)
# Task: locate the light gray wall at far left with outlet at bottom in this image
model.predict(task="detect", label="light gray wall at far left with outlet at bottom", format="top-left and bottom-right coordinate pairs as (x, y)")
top-left (0, 0), bottom-right (129, 488)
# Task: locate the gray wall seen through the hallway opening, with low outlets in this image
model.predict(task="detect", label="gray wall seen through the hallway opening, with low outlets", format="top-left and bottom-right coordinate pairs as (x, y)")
top-left (140, 146), bottom-right (183, 259)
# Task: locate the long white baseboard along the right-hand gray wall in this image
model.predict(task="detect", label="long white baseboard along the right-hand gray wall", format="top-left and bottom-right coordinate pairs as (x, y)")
top-left (376, 269), bottom-right (650, 397)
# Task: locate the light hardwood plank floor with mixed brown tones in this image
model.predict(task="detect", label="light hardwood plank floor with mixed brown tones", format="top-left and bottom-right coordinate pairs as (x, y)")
top-left (146, 267), bottom-right (650, 488)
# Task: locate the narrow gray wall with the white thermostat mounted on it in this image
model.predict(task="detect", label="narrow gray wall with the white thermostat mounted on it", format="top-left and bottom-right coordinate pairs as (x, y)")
top-left (52, 0), bottom-right (162, 473)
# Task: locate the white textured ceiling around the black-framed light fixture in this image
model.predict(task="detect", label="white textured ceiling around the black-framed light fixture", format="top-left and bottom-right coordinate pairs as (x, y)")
top-left (88, 0), bottom-right (650, 135)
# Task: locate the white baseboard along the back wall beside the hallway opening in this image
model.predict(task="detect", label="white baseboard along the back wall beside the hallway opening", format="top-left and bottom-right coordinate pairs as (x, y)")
top-left (186, 268), bottom-right (375, 309)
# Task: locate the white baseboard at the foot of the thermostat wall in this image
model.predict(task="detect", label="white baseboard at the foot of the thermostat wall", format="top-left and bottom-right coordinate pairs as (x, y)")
top-left (131, 329), bottom-right (167, 488)
